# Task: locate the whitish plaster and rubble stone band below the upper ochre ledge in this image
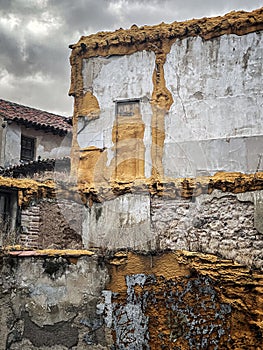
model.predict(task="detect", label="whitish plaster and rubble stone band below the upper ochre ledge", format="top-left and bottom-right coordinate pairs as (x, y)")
top-left (83, 190), bottom-right (263, 268)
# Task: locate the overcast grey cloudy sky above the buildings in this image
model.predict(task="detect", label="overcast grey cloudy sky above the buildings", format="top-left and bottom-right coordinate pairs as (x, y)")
top-left (0, 0), bottom-right (263, 115)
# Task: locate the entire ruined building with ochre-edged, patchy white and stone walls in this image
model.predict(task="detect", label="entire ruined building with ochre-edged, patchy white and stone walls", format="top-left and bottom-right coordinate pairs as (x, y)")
top-left (0, 8), bottom-right (263, 350)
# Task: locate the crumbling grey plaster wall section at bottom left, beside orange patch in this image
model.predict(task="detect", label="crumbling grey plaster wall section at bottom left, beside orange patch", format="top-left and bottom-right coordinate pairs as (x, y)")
top-left (0, 256), bottom-right (107, 350)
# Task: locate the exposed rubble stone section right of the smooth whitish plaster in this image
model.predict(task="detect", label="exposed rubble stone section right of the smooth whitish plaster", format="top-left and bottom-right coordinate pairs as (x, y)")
top-left (151, 192), bottom-right (263, 268)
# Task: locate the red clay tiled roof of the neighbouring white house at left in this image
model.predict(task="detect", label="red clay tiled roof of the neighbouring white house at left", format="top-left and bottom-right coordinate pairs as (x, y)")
top-left (0, 99), bottom-right (71, 134)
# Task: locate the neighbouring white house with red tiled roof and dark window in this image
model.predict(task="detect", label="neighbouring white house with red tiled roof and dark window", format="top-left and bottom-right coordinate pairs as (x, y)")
top-left (0, 99), bottom-right (71, 168)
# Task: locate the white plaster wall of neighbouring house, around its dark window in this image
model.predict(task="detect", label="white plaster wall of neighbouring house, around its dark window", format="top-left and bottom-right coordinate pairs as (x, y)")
top-left (4, 123), bottom-right (71, 166)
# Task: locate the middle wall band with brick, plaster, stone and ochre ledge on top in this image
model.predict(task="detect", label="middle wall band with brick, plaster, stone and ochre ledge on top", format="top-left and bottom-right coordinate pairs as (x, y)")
top-left (2, 173), bottom-right (263, 268)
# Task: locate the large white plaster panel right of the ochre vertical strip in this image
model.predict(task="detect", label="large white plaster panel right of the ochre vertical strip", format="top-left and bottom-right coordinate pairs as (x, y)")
top-left (163, 32), bottom-right (263, 177)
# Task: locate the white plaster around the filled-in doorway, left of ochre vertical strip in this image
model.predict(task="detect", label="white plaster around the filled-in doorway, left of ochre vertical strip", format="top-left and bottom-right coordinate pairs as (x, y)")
top-left (78, 51), bottom-right (155, 176)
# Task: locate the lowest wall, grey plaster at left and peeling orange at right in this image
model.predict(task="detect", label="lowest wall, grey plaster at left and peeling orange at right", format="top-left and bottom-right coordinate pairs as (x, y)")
top-left (0, 251), bottom-right (263, 350)
